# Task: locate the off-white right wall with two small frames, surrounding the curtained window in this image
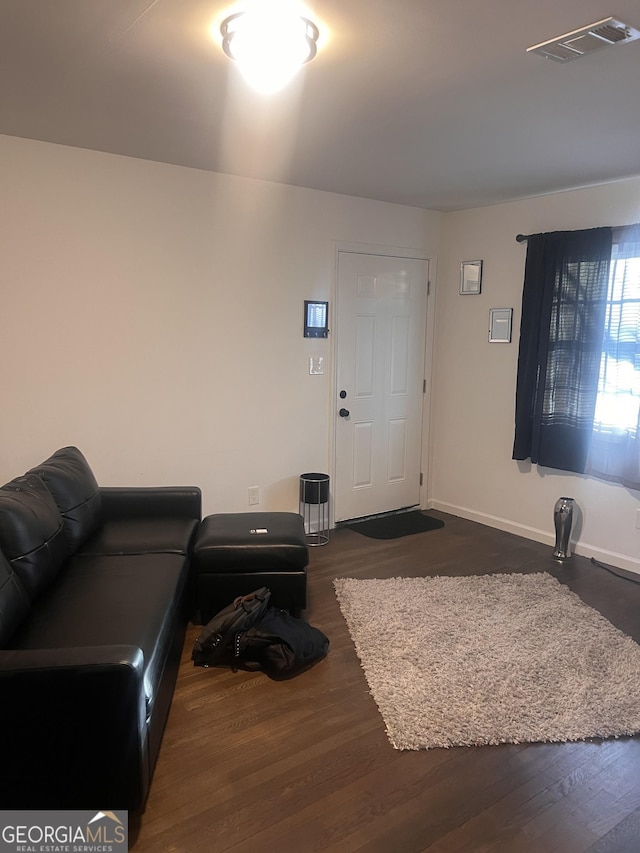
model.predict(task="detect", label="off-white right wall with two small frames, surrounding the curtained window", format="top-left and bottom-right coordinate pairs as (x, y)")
top-left (429, 178), bottom-right (640, 571)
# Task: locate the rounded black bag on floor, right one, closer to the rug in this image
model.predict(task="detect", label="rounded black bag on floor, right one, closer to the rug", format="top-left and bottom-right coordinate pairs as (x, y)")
top-left (235, 607), bottom-right (329, 679)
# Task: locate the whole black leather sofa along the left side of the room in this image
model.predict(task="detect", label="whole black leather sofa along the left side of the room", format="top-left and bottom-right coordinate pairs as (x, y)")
top-left (0, 447), bottom-right (201, 812)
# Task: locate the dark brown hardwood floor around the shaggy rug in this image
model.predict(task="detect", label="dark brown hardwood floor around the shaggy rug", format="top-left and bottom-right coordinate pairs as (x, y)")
top-left (130, 512), bottom-right (640, 853)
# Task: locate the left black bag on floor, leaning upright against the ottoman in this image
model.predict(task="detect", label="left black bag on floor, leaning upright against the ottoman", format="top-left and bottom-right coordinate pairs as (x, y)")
top-left (191, 586), bottom-right (271, 666)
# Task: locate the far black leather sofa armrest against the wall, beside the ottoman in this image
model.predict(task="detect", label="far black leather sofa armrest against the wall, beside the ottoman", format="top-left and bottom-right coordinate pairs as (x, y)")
top-left (100, 486), bottom-right (202, 521)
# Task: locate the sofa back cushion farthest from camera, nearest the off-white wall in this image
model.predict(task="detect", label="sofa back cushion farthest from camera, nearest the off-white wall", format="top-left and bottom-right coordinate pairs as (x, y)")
top-left (28, 447), bottom-right (102, 554)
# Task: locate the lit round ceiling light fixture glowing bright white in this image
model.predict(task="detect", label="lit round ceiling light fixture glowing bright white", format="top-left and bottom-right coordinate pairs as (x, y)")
top-left (220, 0), bottom-right (320, 94)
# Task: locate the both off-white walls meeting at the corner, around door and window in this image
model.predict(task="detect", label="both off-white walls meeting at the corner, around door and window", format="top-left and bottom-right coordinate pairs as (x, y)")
top-left (5, 136), bottom-right (640, 568)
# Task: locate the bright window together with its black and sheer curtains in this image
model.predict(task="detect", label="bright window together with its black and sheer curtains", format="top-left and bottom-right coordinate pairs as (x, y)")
top-left (513, 225), bottom-right (640, 489)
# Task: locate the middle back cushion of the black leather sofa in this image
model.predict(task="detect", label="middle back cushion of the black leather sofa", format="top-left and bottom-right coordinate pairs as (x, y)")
top-left (0, 474), bottom-right (69, 601)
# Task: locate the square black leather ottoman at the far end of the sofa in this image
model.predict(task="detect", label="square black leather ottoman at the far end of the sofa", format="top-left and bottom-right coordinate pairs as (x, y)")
top-left (192, 512), bottom-right (309, 625)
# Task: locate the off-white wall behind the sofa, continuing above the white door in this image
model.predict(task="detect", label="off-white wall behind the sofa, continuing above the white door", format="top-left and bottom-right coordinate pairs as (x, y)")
top-left (0, 136), bottom-right (441, 513)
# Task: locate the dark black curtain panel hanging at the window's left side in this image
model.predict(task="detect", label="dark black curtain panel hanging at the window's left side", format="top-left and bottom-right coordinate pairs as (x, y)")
top-left (513, 228), bottom-right (612, 473)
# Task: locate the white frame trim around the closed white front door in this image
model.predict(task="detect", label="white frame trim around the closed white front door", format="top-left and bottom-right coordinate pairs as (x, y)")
top-left (329, 241), bottom-right (436, 527)
